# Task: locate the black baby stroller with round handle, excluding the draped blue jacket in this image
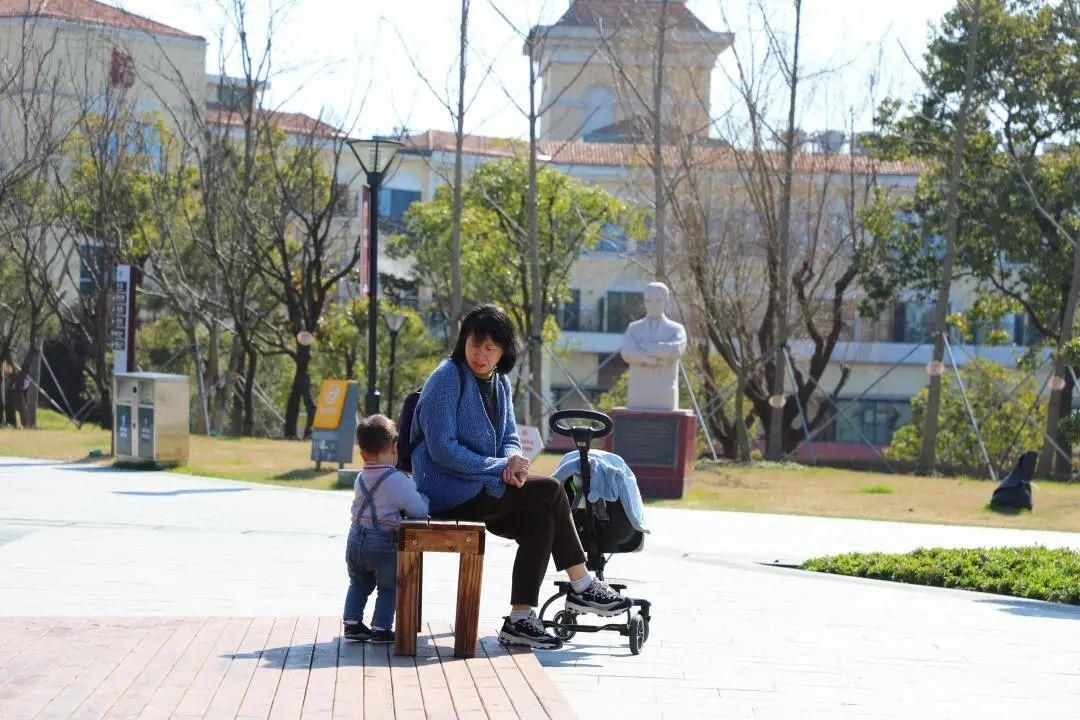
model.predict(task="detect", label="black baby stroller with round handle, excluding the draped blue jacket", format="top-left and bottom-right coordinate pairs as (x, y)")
top-left (540, 410), bottom-right (649, 655)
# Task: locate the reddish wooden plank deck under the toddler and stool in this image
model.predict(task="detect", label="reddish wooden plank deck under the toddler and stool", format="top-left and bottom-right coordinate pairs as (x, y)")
top-left (0, 617), bottom-right (573, 720)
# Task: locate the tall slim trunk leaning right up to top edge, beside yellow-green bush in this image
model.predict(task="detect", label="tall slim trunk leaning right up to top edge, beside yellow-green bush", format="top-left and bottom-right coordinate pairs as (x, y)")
top-left (916, 0), bottom-right (980, 475)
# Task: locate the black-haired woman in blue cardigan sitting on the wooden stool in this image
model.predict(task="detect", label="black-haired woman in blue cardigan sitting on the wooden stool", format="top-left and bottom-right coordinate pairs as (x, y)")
top-left (411, 304), bottom-right (632, 649)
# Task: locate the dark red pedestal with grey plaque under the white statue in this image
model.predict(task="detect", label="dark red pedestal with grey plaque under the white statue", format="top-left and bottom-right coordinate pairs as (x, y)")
top-left (605, 408), bottom-right (698, 498)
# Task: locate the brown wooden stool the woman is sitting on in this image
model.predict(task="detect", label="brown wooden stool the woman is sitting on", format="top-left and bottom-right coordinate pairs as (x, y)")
top-left (394, 520), bottom-right (484, 657)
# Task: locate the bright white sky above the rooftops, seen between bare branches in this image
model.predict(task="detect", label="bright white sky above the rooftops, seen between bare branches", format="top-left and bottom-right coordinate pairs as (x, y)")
top-left (113, 0), bottom-right (955, 137)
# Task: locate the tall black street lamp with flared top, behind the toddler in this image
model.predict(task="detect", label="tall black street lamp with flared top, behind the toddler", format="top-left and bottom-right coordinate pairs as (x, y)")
top-left (347, 137), bottom-right (402, 415)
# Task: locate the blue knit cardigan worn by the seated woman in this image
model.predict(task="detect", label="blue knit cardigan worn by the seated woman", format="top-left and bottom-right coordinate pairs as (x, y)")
top-left (410, 359), bottom-right (522, 514)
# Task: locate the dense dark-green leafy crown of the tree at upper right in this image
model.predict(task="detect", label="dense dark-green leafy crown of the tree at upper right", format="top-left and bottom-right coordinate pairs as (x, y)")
top-left (864, 0), bottom-right (1080, 342)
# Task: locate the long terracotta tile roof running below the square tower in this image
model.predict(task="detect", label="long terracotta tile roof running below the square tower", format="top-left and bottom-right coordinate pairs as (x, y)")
top-left (402, 130), bottom-right (926, 175)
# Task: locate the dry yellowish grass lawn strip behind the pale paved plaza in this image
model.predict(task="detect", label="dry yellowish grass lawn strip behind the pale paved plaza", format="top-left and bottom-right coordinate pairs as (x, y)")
top-left (6, 412), bottom-right (1080, 532)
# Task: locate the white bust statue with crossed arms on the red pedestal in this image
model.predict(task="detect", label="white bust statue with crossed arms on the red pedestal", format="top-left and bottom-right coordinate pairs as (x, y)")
top-left (622, 283), bottom-right (686, 410)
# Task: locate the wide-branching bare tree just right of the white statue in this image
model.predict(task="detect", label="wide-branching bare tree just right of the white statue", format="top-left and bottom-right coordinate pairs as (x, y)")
top-left (665, 2), bottom-right (898, 458)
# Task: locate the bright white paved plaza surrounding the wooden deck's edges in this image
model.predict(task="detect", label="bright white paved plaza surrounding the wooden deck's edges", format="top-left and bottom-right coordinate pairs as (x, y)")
top-left (0, 459), bottom-right (1080, 720)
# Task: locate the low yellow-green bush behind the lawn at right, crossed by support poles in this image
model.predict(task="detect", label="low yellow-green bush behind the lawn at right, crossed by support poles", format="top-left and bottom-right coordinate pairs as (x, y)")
top-left (885, 357), bottom-right (1047, 467)
